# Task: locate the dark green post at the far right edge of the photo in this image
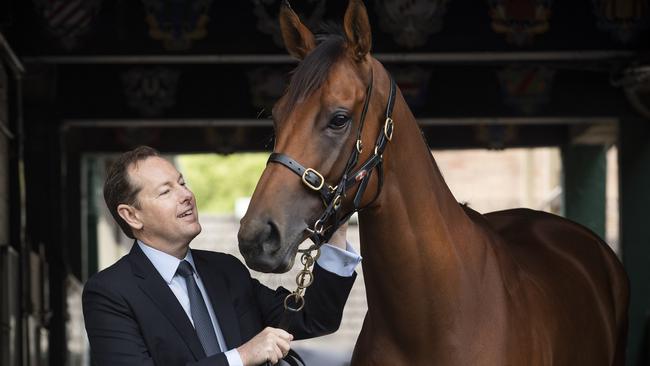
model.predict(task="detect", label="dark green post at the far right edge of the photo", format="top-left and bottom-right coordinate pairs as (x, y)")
top-left (619, 119), bottom-right (650, 366)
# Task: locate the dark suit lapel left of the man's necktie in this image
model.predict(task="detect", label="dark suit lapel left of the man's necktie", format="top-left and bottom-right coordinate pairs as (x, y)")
top-left (129, 243), bottom-right (205, 360)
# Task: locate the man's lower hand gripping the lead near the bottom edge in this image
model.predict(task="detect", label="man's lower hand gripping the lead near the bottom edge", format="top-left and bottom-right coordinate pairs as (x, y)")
top-left (237, 327), bottom-right (293, 366)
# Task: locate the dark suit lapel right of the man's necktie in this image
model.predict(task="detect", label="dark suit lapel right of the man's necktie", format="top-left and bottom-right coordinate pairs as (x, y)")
top-left (192, 251), bottom-right (241, 349)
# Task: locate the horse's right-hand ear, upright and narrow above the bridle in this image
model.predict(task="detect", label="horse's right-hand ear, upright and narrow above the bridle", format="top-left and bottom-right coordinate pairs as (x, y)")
top-left (343, 0), bottom-right (372, 61)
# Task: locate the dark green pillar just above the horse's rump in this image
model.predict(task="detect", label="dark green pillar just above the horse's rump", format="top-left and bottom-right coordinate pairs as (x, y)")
top-left (562, 145), bottom-right (607, 238)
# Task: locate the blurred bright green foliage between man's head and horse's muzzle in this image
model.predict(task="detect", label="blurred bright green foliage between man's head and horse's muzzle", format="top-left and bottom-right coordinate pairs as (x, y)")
top-left (176, 153), bottom-right (269, 213)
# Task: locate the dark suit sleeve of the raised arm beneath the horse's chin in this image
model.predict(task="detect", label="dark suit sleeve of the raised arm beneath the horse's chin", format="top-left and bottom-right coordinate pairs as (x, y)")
top-left (246, 263), bottom-right (356, 339)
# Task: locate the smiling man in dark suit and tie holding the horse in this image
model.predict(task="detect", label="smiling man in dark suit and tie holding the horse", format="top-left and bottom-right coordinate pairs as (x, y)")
top-left (83, 147), bottom-right (360, 366)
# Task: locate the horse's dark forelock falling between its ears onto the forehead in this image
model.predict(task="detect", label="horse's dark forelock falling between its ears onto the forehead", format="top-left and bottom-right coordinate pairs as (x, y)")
top-left (284, 26), bottom-right (345, 116)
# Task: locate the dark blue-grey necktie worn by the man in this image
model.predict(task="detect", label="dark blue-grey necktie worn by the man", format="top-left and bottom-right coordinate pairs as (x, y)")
top-left (176, 260), bottom-right (221, 356)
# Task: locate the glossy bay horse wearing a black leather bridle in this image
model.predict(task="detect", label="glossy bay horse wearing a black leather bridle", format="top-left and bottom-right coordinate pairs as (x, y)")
top-left (238, 0), bottom-right (629, 366)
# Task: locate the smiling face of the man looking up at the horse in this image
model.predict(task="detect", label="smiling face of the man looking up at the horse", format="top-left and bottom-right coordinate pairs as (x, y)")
top-left (129, 156), bottom-right (201, 249)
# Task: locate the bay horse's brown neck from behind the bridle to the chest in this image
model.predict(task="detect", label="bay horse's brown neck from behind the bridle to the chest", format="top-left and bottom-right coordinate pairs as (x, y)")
top-left (360, 82), bottom-right (492, 346)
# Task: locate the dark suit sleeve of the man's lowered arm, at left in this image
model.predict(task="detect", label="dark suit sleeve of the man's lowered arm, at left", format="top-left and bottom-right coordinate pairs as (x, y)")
top-left (82, 278), bottom-right (228, 366)
